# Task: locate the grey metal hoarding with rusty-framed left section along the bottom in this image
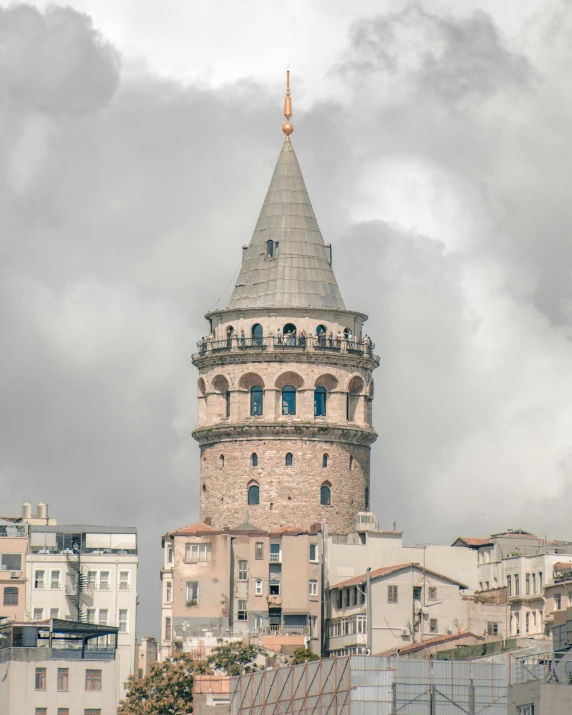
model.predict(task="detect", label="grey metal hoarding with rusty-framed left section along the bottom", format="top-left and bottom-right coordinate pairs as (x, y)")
top-left (230, 655), bottom-right (508, 715)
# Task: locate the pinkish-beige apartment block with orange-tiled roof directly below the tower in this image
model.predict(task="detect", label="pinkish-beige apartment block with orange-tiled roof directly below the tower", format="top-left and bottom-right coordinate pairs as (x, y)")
top-left (161, 521), bottom-right (322, 658)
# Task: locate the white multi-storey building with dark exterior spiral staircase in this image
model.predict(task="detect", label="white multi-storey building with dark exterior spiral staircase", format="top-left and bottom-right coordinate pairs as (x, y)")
top-left (26, 524), bottom-right (138, 701)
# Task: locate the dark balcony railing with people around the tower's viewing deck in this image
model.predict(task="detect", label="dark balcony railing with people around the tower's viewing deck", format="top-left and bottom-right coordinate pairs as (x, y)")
top-left (193, 335), bottom-right (379, 365)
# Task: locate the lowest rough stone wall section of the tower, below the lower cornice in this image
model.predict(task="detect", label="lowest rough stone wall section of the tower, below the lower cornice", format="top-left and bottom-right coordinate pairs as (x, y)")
top-left (201, 439), bottom-right (369, 533)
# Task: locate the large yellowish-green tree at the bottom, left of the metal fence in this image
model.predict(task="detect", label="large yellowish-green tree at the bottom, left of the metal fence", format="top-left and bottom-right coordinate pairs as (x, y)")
top-left (117, 655), bottom-right (206, 715)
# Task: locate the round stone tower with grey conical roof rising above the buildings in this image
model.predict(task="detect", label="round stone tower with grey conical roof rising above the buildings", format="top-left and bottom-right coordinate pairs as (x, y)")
top-left (193, 84), bottom-right (379, 533)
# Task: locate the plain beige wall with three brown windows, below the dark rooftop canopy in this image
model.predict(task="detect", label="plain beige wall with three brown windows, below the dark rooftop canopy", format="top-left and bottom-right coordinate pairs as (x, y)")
top-left (0, 648), bottom-right (119, 715)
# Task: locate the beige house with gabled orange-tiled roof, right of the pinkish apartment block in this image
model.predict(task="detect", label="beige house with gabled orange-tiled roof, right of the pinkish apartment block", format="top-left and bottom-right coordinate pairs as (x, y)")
top-left (327, 563), bottom-right (506, 655)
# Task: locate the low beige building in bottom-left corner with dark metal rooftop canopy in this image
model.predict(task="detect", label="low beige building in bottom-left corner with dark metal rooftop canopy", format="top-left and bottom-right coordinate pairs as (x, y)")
top-left (0, 619), bottom-right (119, 715)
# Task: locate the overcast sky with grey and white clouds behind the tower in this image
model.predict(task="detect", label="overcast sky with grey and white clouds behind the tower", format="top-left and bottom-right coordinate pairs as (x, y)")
top-left (0, 0), bottom-right (572, 635)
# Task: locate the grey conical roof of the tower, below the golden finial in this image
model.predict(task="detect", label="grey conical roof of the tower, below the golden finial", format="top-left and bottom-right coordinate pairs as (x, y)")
top-left (228, 138), bottom-right (345, 310)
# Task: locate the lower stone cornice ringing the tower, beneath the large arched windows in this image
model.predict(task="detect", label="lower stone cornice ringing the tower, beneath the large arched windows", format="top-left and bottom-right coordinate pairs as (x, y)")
top-left (193, 422), bottom-right (377, 447)
